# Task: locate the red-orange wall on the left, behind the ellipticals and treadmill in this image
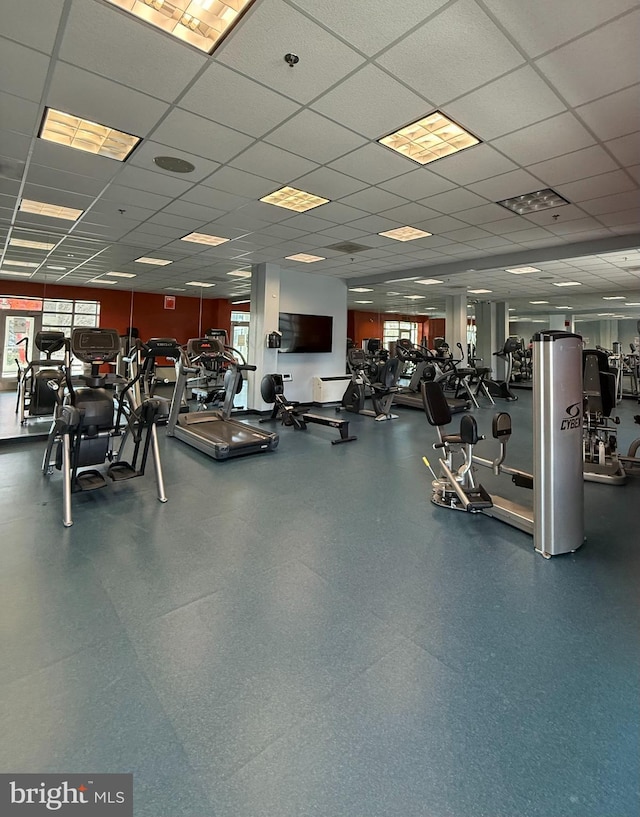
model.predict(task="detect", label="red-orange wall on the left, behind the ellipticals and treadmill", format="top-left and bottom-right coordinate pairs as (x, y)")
top-left (0, 281), bottom-right (240, 343)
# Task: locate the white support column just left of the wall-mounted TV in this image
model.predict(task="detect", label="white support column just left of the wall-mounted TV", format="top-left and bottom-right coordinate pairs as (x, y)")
top-left (247, 264), bottom-right (280, 411)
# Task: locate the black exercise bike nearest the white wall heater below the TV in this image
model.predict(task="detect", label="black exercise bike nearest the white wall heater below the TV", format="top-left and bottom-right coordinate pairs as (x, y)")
top-left (336, 347), bottom-right (402, 421)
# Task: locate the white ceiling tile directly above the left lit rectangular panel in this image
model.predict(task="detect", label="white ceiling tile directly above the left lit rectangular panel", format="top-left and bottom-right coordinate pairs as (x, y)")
top-left (46, 62), bottom-right (167, 136)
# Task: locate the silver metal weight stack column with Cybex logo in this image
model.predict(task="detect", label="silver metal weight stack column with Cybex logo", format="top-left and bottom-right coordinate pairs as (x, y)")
top-left (533, 330), bottom-right (584, 558)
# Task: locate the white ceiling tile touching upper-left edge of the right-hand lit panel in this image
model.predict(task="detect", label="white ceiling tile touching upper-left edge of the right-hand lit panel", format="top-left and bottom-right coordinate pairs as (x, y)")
top-left (312, 65), bottom-right (430, 139)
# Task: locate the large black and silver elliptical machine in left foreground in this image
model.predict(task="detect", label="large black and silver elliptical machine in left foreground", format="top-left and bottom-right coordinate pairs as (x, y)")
top-left (42, 328), bottom-right (178, 527)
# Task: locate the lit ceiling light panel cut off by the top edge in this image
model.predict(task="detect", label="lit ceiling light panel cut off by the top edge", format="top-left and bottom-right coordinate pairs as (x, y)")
top-left (108, 0), bottom-right (253, 54)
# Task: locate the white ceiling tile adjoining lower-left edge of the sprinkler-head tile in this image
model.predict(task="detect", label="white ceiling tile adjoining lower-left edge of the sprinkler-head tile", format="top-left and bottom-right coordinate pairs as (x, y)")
top-left (180, 61), bottom-right (300, 137)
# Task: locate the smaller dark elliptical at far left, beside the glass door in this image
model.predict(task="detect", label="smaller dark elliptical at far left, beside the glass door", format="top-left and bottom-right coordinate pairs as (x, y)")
top-left (16, 331), bottom-right (66, 425)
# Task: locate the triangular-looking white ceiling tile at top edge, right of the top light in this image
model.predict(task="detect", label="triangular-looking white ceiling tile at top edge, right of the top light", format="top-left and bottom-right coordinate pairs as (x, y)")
top-left (291, 0), bottom-right (447, 56)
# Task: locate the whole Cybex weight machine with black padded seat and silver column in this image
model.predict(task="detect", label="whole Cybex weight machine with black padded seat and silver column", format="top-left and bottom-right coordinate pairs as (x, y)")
top-left (422, 330), bottom-right (584, 558)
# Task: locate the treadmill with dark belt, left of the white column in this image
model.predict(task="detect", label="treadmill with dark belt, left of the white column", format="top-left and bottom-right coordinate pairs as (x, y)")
top-left (167, 337), bottom-right (279, 460)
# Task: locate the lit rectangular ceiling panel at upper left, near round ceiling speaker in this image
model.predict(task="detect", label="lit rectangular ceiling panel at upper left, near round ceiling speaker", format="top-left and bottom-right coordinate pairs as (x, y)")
top-left (40, 108), bottom-right (141, 162)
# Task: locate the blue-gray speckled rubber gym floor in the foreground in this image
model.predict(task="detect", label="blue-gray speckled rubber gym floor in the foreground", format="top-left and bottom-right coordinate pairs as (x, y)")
top-left (0, 391), bottom-right (640, 817)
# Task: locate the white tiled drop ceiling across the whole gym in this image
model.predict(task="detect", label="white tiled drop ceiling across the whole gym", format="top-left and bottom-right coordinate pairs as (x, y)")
top-left (0, 0), bottom-right (640, 318)
